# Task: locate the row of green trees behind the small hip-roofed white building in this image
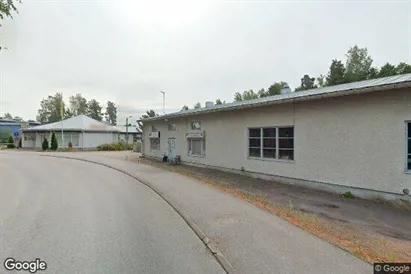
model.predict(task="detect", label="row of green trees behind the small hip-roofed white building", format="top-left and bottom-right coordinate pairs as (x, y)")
top-left (37, 92), bottom-right (117, 125)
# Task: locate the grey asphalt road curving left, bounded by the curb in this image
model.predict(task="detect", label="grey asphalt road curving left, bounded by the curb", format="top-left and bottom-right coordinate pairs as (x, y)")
top-left (0, 154), bottom-right (225, 274)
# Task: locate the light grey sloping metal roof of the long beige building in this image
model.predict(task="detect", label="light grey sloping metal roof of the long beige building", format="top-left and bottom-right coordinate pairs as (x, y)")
top-left (139, 73), bottom-right (411, 122)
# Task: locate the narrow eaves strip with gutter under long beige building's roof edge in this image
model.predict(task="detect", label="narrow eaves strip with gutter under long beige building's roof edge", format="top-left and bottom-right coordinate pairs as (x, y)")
top-left (141, 82), bottom-right (411, 122)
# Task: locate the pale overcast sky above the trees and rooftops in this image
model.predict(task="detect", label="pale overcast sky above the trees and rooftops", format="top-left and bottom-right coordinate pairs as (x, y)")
top-left (0, 0), bottom-right (411, 122)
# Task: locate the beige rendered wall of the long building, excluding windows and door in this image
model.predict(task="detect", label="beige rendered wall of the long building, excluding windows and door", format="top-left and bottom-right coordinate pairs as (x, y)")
top-left (144, 90), bottom-right (411, 193)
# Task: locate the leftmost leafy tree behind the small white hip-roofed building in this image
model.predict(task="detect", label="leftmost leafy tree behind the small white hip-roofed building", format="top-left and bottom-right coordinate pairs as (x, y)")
top-left (38, 93), bottom-right (65, 123)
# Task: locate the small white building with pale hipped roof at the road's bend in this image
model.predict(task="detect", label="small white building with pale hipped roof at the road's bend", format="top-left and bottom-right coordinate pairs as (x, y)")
top-left (22, 115), bottom-right (121, 149)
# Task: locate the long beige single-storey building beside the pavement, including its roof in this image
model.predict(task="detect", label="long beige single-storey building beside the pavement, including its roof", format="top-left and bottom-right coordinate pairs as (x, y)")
top-left (142, 74), bottom-right (411, 199)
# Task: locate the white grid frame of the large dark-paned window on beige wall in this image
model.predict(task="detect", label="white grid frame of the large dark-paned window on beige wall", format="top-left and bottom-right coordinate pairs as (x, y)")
top-left (246, 125), bottom-right (295, 163)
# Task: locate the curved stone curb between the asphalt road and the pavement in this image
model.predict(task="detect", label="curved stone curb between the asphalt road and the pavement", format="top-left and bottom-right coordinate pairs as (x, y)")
top-left (39, 155), bottom-right (235, 274)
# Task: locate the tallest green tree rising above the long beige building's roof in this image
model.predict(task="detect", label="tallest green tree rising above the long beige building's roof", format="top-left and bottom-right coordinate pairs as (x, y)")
top-left (345, 45), bottom-right (373, 83)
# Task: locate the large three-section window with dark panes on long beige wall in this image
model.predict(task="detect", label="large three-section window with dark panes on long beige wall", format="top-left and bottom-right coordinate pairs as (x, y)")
top-left (248, 127), bottom-right (294, 160)
